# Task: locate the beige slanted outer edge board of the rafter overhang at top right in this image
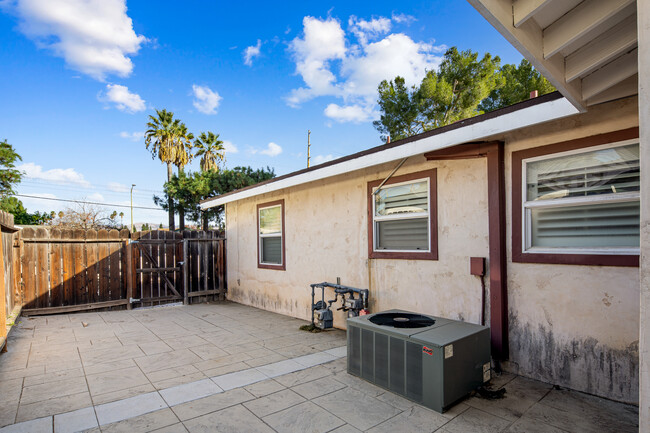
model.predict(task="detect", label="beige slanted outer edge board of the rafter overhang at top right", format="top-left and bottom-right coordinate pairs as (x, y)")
top-left (467, 0), bottom-right (587, 112)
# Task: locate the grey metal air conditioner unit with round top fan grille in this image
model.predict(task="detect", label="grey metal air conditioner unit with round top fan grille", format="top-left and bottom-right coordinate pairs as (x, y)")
top-left (347, 310), bottom-right (490, 413)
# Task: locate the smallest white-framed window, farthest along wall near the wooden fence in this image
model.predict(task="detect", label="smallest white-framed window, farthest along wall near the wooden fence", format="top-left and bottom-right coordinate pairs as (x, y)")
top-left (257, 203), bottom-right (284, 267)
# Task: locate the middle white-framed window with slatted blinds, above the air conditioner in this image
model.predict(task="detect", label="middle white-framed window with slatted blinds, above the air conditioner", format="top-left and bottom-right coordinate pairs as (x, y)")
top-left (372, 178), bottom-right (431, 252)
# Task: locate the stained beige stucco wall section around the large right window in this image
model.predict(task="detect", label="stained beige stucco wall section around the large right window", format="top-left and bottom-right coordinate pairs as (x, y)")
top-left (505, 98), bottom-right (639, 402)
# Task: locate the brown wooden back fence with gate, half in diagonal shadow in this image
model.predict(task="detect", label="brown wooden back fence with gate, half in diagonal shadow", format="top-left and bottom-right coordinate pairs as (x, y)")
top-left (18, 227), bottom-right (226, 315)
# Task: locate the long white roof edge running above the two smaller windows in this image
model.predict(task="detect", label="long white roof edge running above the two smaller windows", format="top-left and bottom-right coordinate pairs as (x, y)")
top-left (201, 93), bottom-right (578, 209)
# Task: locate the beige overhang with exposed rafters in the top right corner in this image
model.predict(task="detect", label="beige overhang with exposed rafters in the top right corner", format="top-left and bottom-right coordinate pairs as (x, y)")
top-left (468, 0), bottom-right (638, 111)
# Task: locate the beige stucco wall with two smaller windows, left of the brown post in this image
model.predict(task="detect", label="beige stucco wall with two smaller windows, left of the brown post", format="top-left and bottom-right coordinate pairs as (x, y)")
top-left (226, 157), bottom-right (488, 328)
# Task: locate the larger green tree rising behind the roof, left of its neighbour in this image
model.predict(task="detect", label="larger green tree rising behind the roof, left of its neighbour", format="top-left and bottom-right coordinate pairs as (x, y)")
top-left (373, 47), bottom-right (503, 140)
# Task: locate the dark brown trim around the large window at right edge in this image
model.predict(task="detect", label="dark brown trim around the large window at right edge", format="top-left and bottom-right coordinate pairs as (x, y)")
top-left (512, 127), bottom-right (639, 266)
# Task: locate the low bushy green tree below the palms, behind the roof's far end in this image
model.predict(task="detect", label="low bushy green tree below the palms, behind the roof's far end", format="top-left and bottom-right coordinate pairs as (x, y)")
top-left (153, 167), bottom-right (275, 230)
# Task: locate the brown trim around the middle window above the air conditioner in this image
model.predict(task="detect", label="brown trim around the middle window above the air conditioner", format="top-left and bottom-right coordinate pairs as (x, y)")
top-left (368, 168), bottom-right (438, 260)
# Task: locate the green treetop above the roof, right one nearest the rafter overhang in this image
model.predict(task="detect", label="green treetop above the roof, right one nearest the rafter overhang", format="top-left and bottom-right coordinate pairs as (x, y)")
top-left (479, 59), bottom-right (555, 111)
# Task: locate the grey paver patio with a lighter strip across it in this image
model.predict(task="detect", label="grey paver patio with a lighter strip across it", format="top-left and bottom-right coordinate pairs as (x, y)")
top-left (0, 302), bottom-right (638, 433)
